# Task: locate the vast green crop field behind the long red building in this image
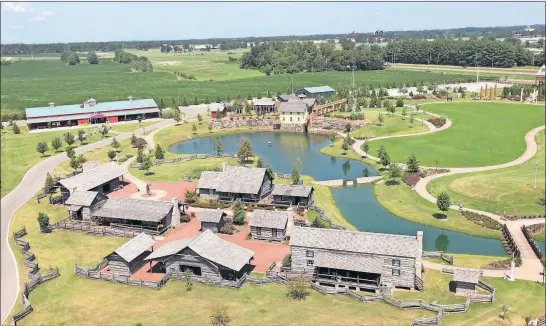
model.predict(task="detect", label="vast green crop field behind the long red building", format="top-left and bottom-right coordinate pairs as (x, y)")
top-left (0, 57), bottom-right (492, 114)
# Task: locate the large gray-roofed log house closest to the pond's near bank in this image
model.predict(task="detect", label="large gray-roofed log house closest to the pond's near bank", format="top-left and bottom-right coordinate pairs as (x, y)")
top-left (197, 166), bottom-right (273, 202)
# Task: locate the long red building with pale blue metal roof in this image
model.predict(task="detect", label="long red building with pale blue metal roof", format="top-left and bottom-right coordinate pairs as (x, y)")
top-left (26, 97), bottom-right (159, 129)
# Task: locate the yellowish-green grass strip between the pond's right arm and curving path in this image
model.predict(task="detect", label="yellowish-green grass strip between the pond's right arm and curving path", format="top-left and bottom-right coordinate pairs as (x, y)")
top-left (374, 181), bottom-right (500, 239)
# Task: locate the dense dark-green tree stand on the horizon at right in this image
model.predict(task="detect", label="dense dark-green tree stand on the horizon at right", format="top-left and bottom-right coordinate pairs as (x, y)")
top-left (384, 39), bottom-right (544, 68)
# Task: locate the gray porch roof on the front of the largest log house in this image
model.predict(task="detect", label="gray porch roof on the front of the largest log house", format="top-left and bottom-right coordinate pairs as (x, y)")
top-left (314, 251), bottom-right (383, 274)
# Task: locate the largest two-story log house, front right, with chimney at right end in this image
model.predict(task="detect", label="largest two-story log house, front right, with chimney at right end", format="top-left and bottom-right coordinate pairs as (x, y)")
top-left (290, 226), bottom-right (423, 292)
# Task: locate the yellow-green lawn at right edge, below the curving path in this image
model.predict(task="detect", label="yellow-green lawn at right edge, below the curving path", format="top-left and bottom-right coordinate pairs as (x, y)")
top-left (427, 131), bottom-right (545, 216)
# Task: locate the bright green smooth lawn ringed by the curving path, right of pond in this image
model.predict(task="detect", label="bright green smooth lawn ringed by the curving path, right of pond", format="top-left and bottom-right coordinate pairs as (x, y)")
top-left (370, 102), bottom-right (545, 167)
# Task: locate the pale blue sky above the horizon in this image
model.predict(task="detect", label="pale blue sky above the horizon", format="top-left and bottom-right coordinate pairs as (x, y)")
top-left (1, 2), bottom-right (546, 44)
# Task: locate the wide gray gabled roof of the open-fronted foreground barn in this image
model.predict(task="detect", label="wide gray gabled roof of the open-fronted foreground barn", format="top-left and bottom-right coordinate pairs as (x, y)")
top-left (146, 230), bottom-right (255, 271)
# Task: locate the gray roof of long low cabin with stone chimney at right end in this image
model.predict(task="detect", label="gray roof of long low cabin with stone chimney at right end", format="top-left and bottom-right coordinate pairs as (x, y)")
top-left (93, 198), bottom-right (173, 222)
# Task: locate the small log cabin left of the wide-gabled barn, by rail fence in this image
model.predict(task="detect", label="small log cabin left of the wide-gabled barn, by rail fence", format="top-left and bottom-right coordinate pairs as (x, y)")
top-left (105, 233), bottom-right (155, 276)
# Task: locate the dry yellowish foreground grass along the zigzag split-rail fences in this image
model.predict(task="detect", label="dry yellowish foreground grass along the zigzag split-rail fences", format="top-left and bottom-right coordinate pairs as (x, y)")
top-left (10, 194), bottom-right (544, 325)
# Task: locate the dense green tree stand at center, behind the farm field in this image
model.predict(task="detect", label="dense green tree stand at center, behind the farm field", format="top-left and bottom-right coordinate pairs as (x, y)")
top-left (240, 41), bottom-right (383, 75)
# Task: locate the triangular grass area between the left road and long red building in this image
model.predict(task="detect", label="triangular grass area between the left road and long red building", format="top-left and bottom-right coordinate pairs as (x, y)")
top-left (0, 126), bottom-right (111, 197)
